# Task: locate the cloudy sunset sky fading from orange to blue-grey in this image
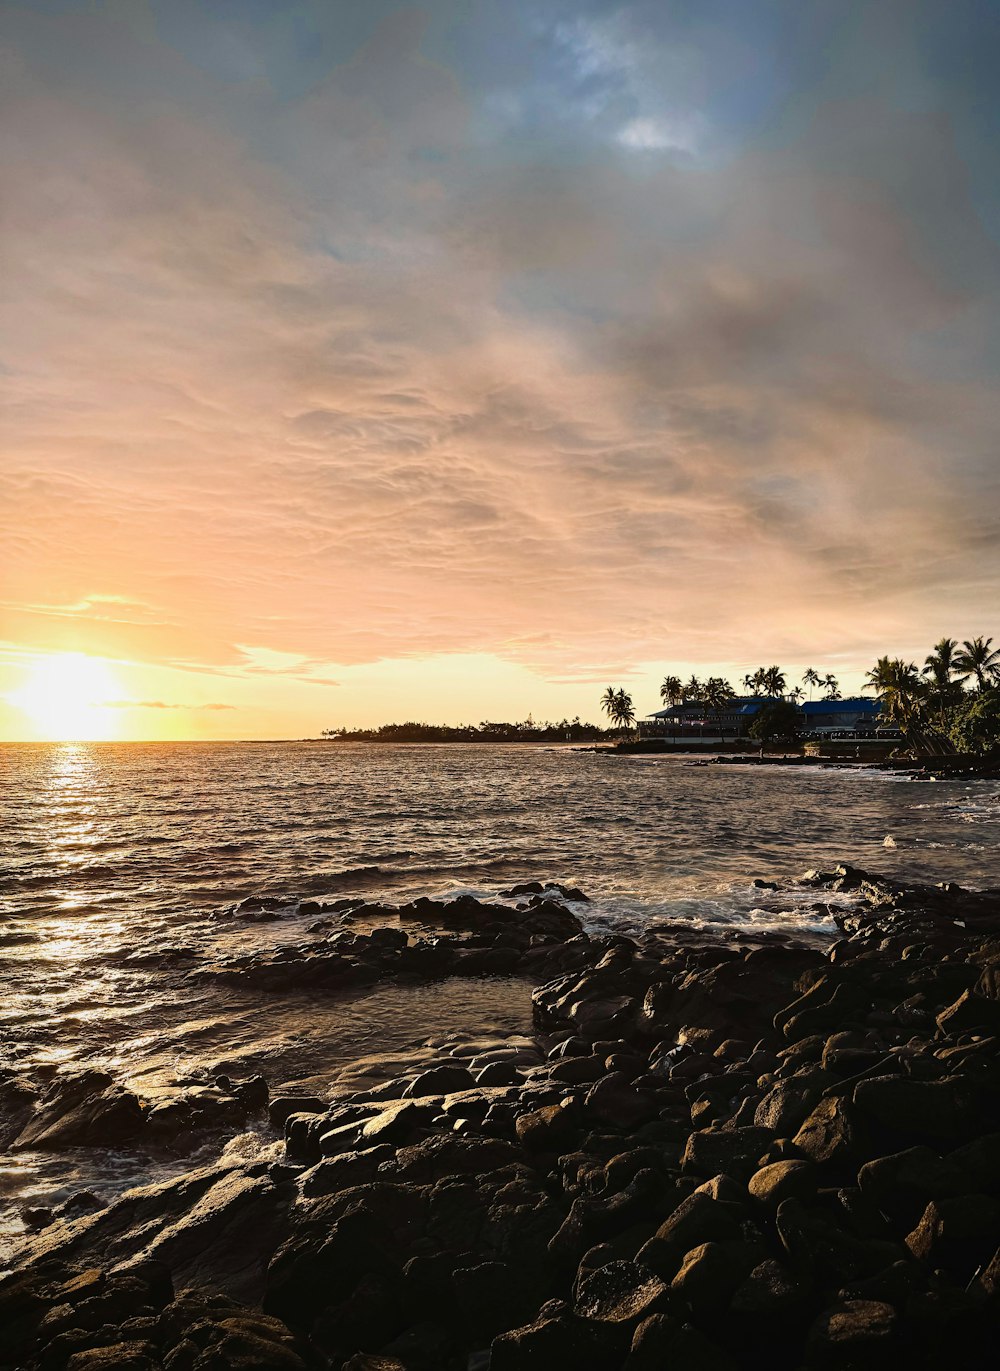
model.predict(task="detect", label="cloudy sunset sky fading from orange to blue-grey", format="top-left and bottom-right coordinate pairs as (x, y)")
top-left (0, 0), bottom-right (1000, 740)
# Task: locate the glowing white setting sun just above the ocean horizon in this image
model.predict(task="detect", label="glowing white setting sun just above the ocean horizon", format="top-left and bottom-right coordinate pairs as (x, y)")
top-left (8, 653), bottom-right (121, 742)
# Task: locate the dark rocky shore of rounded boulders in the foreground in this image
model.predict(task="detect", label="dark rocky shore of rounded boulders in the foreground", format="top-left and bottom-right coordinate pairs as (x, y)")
top-left (0, 866), bottom-right (1000, 1371)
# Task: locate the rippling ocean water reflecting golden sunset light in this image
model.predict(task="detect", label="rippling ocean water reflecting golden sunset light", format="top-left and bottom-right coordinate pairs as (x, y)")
top-left (0, 743), bottom-right (1000, 1235)
